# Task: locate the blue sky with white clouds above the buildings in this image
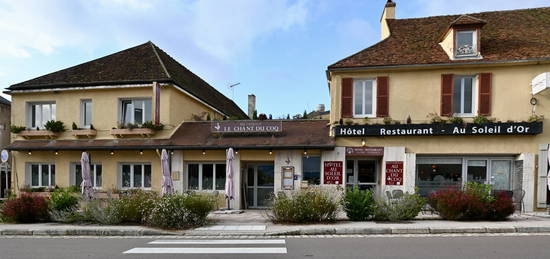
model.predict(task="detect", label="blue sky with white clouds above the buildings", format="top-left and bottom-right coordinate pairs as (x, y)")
top-left (0, 0), bottom-right (550, 118)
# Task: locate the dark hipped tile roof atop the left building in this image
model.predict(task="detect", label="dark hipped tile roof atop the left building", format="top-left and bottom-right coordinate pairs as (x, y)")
top-left (7, 42), bottom-right (246, 118)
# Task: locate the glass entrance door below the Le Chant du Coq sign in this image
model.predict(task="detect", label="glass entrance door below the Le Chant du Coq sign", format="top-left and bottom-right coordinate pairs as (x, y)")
top-left (246, 164), bottom-right (275, 208)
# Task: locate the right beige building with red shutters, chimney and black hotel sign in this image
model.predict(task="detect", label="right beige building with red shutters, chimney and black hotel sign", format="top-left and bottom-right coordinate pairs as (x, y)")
top-left (327, 0), bottom-right (550, 211)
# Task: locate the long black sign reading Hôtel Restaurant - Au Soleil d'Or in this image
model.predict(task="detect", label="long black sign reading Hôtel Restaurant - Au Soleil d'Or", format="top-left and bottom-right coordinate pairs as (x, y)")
top-left (335, 122), bottom-right (542, 137)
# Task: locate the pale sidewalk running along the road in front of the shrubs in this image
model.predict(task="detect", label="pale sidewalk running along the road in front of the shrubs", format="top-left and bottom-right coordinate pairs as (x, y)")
top-left (0, 210), bottom-right (550, 237)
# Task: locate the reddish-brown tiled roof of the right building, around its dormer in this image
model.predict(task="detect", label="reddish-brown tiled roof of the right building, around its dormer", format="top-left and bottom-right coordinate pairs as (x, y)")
top-left (328, 7), bottom-right (550, 70)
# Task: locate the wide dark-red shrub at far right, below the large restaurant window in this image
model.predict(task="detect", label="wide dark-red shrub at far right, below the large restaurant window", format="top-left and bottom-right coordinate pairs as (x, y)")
top-left (429, 183), bottom-right (514, 220)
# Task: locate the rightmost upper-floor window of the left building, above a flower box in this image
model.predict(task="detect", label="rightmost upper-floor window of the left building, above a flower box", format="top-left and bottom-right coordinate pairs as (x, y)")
top-left (120, 98), bottom-right (153, 124)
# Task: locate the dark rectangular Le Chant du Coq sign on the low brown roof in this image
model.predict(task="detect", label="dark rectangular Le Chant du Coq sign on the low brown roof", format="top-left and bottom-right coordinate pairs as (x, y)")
top-left (210, 121), bottom-right (283, 134)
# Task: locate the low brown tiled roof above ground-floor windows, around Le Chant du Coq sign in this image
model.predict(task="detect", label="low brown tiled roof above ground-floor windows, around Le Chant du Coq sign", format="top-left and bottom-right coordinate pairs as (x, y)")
top-left (8, 120), bottom-right (335, 150)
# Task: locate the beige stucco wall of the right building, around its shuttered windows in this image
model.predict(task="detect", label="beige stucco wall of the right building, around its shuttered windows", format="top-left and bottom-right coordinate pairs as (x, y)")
top-left (329, 63), bottom-right (550, 210)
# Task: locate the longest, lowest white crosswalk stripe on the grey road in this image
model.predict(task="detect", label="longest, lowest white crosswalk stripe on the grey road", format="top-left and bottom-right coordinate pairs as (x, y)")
top-left (124, 247), bottom-right (286, 254)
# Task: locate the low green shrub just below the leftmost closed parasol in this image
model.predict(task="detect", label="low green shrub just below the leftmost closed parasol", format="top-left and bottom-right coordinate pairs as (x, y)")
top-left (83, 198), bottom-right (122, 225)
